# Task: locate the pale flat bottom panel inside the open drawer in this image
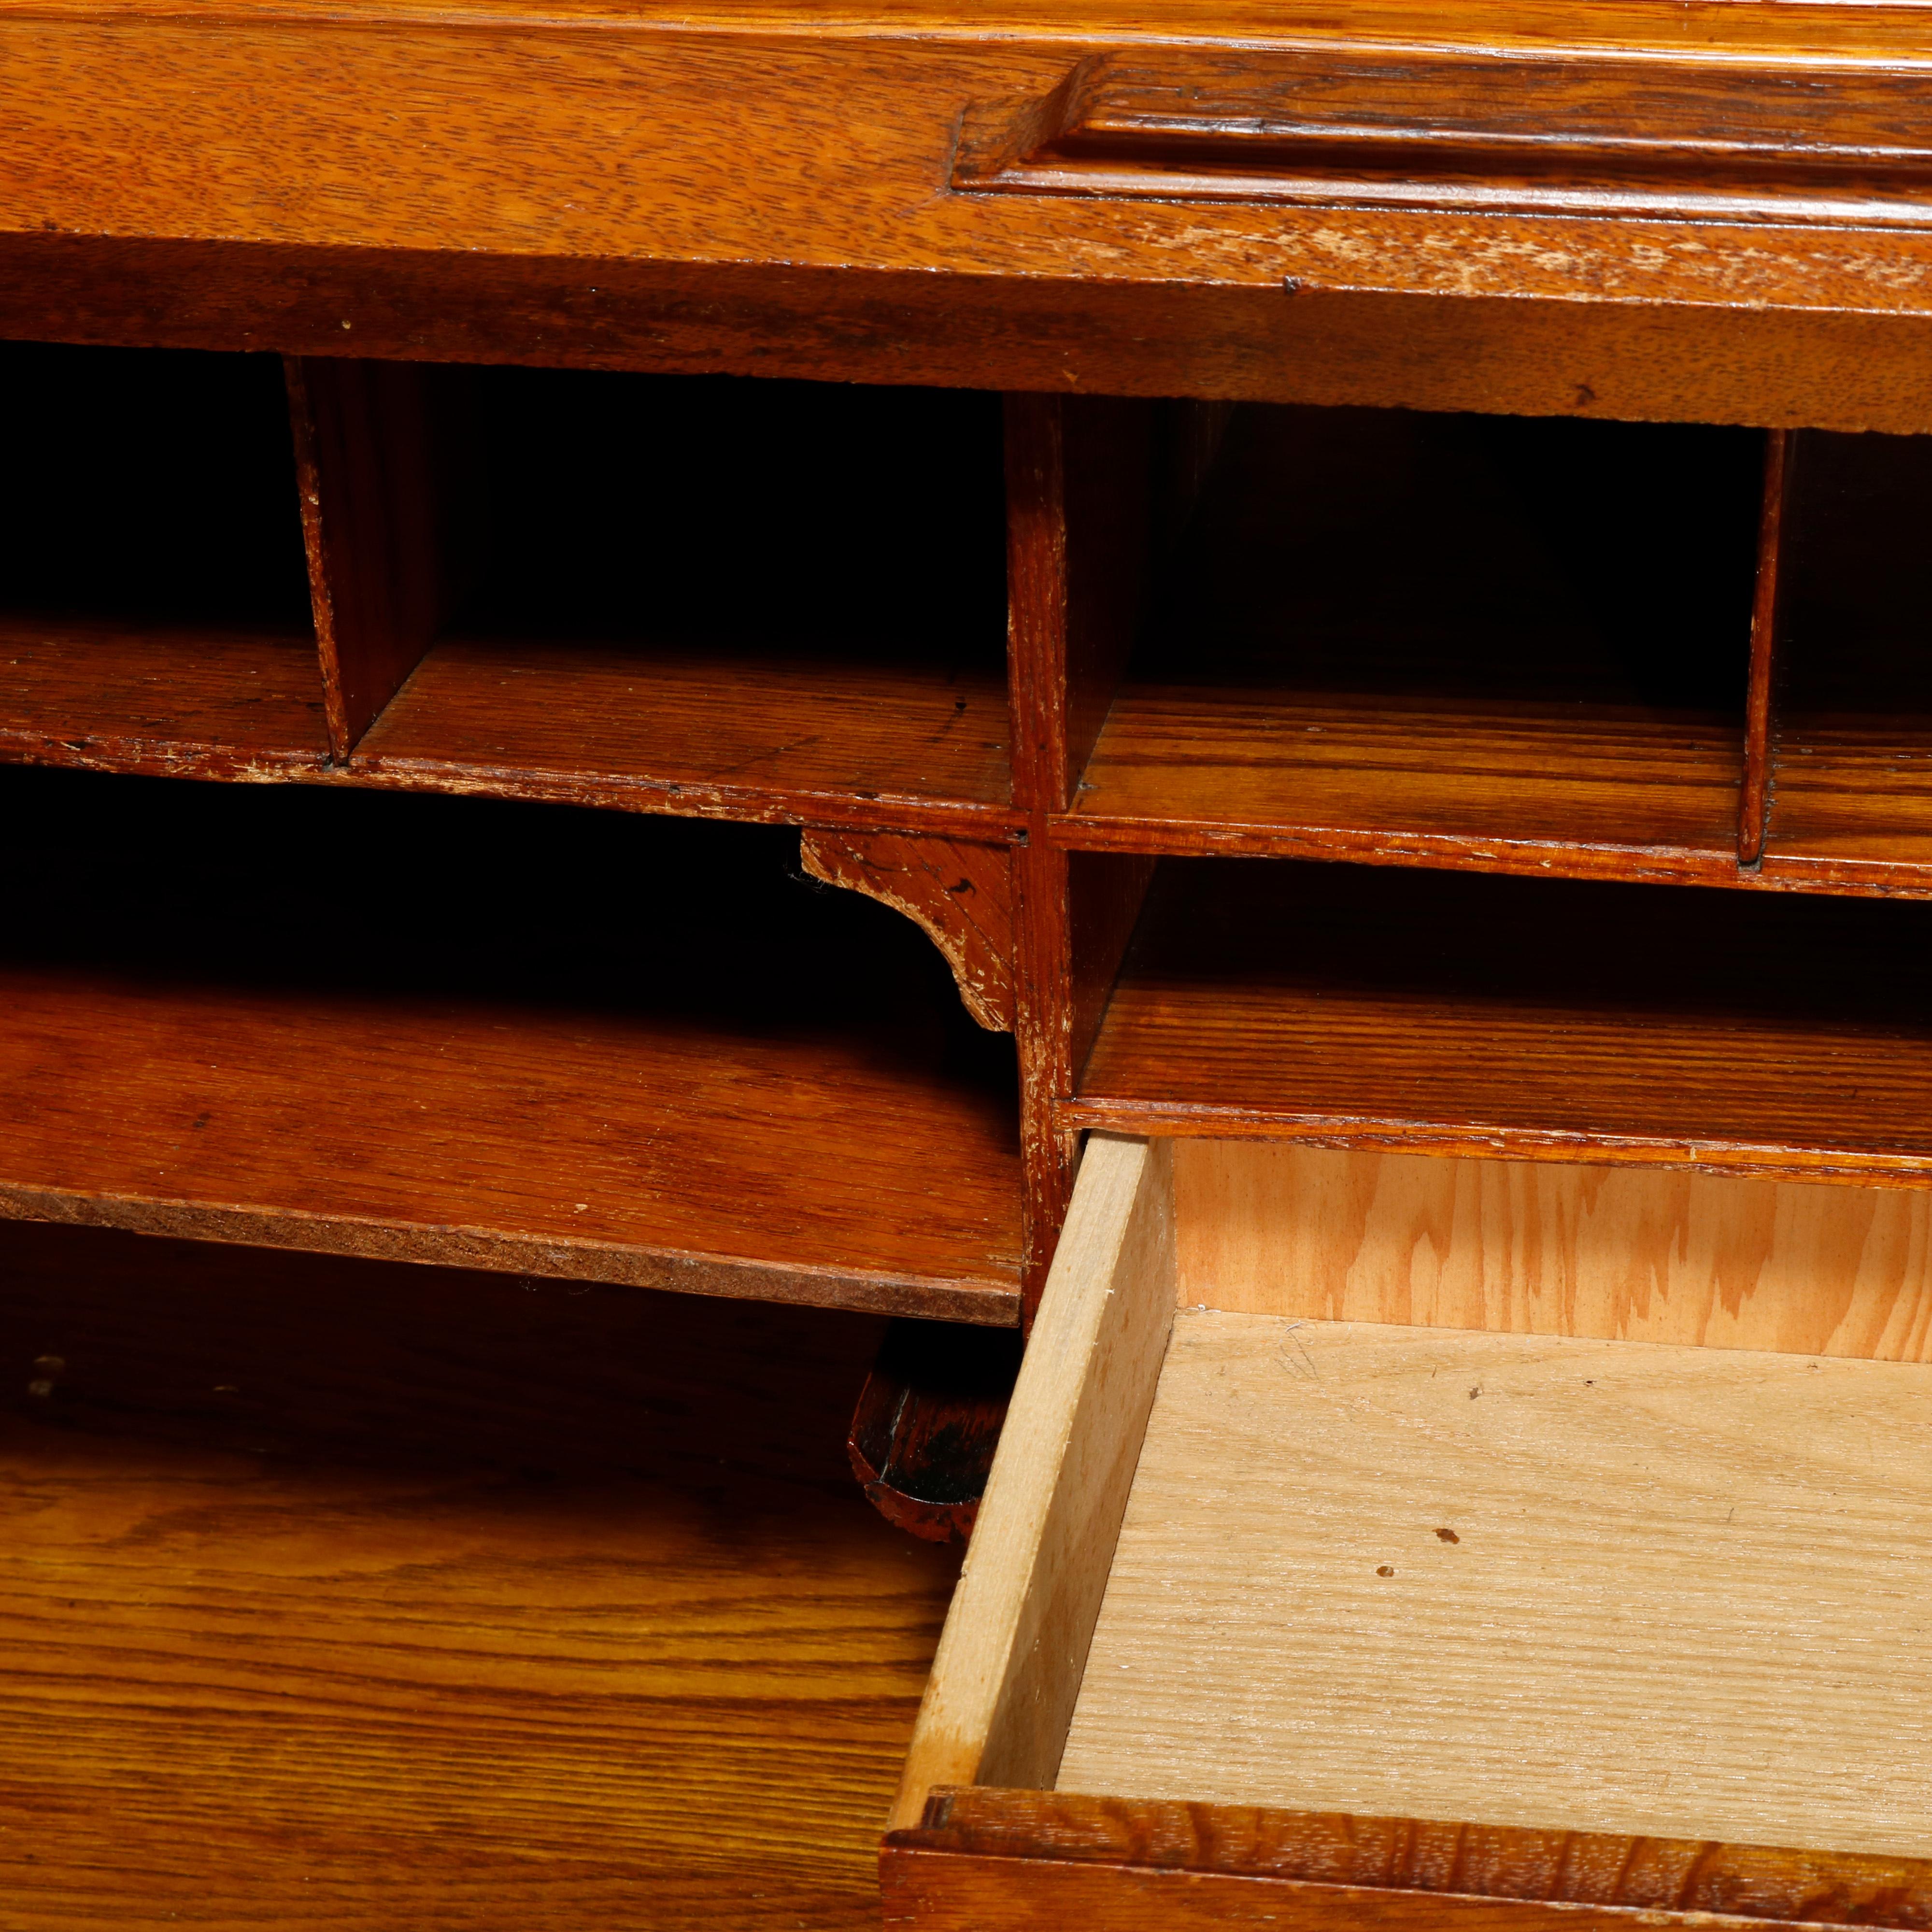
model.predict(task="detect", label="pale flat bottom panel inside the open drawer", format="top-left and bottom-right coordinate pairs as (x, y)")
top-left (1059, 1310), bottom-right (1932, 1857)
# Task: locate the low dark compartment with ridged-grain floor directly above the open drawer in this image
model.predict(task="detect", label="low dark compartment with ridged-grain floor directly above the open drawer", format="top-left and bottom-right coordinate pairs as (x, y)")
top-left (1063, 860), bottom-right (1932, 1182)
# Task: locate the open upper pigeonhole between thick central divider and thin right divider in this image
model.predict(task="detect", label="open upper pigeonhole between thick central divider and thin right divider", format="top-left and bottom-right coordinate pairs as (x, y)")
top-left (1055, 410), bottom-right (1758, 879)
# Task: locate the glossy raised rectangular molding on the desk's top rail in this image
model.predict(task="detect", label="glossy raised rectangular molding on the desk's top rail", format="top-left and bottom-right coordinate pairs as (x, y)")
top-left (952, 48), bottom-right (1932, 226)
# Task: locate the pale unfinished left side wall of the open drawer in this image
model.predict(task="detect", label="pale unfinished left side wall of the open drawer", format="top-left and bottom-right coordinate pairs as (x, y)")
top-left (893, 1136), bottom-right (1173, 1826)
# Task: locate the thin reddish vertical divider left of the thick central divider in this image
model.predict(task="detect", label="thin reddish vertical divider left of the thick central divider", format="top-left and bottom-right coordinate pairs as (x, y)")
top-left (284, 355), bottom-right (444, 763)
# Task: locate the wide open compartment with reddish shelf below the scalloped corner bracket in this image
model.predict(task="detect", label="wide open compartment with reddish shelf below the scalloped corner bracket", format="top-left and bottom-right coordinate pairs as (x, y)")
top-left (0, 773), bottom-right (1020, 1323)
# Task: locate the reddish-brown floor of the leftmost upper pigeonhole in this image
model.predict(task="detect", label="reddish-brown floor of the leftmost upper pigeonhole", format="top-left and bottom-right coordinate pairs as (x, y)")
top-left (0, 612), bottom-right (328, 779)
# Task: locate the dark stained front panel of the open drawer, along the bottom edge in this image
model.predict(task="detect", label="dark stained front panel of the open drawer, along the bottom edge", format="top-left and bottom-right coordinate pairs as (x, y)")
top-left (881, 1789), bottom-right (1932, 1932)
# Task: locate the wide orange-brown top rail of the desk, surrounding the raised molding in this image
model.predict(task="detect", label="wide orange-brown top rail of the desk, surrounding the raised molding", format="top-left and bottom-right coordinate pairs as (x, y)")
top-left (19, 4), bottom-right (1932, 431)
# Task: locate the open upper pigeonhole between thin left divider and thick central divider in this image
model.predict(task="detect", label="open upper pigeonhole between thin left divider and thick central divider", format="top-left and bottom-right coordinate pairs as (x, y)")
top-left (327, 361), bottom-right (1022, 838)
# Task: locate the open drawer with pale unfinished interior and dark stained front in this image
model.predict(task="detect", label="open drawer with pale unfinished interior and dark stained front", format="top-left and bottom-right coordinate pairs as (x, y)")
top-left (881, 1136), bottom-right (1932, 1932)
